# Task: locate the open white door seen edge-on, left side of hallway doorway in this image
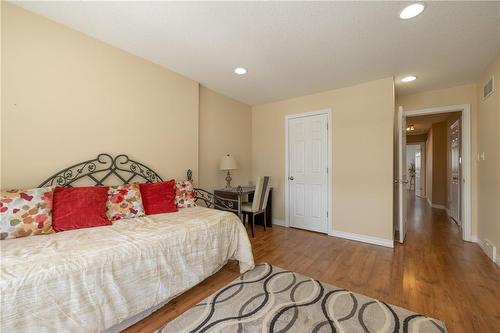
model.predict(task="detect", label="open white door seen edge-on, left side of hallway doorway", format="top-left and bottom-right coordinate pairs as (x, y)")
top-left (394, 107), bottom-right (408, 243)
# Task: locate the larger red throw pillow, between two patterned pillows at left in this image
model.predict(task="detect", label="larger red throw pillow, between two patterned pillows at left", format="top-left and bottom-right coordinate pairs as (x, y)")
top-left (52, 186), bottom-right (111, 232)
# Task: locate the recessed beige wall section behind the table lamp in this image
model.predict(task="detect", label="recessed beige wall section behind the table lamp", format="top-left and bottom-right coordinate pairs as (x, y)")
top-left (198, 86), bottom-right (252, 190)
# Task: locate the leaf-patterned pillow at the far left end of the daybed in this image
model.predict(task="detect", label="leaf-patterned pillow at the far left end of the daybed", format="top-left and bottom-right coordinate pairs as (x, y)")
top-left (0, 187), bottom-right (54, 239)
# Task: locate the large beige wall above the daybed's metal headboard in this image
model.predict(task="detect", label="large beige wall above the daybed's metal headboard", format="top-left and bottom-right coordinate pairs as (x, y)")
top-left (1, 2), bottom-right (198, 187)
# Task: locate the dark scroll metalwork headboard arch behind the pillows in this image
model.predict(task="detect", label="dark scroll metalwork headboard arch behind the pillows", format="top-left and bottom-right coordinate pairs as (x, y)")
top-left (39, 153), bottom-right (163, 187)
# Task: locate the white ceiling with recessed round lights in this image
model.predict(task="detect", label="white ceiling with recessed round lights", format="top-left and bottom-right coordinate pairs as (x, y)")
top-left (12, 1), bottom-right (500, 105)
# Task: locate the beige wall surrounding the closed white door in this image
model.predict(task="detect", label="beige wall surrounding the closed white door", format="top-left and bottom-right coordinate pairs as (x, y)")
top-left (252, 78), bottom-right (394, 240)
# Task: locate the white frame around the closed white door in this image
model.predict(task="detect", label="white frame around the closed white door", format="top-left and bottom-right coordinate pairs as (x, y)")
top-left (285, 108), bottom-right (333, 235)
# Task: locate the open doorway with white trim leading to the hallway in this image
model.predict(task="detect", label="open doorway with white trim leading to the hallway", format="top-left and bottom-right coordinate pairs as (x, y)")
top-left (394, 105), bottom-right (472, 243)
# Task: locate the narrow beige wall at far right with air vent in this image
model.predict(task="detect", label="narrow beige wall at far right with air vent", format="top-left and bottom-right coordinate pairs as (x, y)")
top-left (477, 56), bottom-right (500, 255)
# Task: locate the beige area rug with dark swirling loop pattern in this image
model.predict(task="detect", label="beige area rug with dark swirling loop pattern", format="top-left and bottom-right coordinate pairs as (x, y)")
top-left (158, 264), bottom-right (446, 333)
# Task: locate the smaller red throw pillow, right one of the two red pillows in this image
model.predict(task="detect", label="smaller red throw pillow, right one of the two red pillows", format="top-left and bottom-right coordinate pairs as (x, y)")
top-left (140, 179), bottom-right (177, 215)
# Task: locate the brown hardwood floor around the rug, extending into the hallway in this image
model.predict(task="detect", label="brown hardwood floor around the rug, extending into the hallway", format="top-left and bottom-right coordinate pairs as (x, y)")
top-left (126, 198), bottom-right (500, 333)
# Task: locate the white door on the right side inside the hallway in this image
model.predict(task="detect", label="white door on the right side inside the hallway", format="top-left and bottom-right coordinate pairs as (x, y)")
top-left (448, 120), bottom-right (461, 225)
